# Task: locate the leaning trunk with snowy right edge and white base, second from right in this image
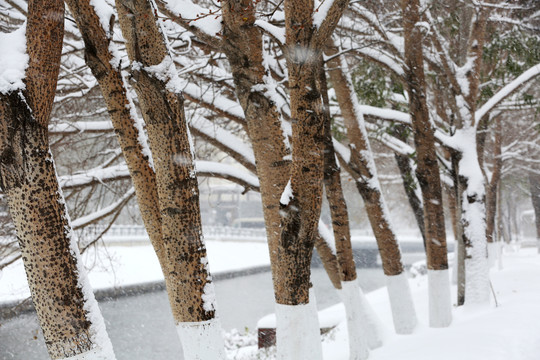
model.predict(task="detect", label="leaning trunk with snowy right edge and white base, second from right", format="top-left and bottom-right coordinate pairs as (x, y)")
top-left (329, 49), bottom-right (417, 334)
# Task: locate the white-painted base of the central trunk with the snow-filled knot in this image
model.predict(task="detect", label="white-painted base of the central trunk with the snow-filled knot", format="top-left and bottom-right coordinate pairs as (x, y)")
top-left (276, 291), bottom-right (322, 360)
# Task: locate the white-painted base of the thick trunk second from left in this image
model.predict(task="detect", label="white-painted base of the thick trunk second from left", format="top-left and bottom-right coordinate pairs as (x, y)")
top-left (176, 318), bottom-right (227, 360)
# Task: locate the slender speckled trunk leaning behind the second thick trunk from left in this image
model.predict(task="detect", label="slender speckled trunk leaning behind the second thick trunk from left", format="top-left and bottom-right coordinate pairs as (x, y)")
top-left (66, 0), bottom-right (167, 269)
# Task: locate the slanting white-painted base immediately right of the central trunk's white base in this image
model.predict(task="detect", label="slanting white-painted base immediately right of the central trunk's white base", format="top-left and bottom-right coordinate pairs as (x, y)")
top-left (338, 281), bottom-right (376, 360)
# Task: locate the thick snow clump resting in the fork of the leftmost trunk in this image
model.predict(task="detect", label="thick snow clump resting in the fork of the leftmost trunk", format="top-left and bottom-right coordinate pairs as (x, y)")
top-left (0, 23), bottom-right (30, 94)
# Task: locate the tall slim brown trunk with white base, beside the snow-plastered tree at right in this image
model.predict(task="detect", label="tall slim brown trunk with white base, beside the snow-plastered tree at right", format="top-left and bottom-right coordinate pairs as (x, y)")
top-left (401, 0), bottom-right (452, 327)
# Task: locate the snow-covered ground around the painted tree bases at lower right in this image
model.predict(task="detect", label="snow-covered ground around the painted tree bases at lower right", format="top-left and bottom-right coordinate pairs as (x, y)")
top-left (233, 249), bottom-right (540, 360)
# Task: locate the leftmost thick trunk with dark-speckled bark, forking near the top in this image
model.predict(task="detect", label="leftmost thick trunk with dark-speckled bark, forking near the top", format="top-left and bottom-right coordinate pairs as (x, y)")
top-left (0, 0), bottom-right (115, 360)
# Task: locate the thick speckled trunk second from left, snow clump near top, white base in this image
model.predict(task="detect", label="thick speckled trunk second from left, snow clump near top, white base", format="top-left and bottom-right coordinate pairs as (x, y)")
top-left (116, 0), bottom-right (225, 359)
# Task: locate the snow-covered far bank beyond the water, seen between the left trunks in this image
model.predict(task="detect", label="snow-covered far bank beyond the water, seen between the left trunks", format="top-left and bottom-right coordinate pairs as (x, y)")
top-left (0, 241), bottom-right (270, 304)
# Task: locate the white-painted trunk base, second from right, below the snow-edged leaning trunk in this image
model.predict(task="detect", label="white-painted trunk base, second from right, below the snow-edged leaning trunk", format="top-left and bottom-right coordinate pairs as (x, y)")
top-left (386, 272), bottom-right (418, 334)
